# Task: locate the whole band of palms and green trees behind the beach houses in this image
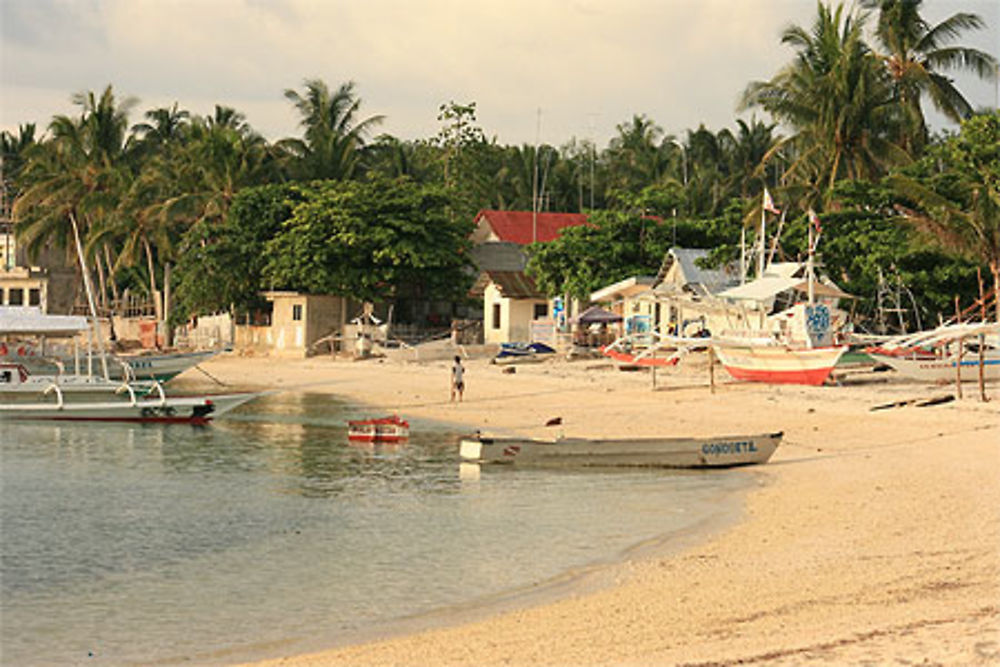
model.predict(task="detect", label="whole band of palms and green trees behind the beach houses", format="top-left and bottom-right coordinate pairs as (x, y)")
top-left (0, 0), bottom-right (1000, 334)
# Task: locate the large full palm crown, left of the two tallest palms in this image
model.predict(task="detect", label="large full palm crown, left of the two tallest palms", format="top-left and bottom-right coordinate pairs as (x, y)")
top-left (741, 4), bottom-right (908, 206)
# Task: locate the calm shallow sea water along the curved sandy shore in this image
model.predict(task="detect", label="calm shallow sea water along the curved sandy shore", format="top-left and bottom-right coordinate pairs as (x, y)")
top-left (0, 394), bottom-right (755, 665)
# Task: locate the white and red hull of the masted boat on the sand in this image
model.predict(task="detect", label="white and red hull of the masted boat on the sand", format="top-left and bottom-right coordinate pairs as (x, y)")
top-left (712, 344), bottom-right (847, 386)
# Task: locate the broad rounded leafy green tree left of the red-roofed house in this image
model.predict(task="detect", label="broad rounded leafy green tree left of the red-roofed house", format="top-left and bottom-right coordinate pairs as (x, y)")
top-left (264, 178), bottom-right (472, 301)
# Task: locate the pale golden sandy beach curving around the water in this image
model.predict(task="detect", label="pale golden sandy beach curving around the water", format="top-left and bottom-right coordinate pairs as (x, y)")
top-left (185, 356), bottom-right (1000, 666)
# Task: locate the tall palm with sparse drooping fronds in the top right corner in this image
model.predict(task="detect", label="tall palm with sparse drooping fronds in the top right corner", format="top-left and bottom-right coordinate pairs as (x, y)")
top-left (861, 0), bottom-right (997, 152)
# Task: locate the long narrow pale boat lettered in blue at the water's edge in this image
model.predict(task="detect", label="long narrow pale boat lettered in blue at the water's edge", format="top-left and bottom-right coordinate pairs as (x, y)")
top-left (459, 432), bottom-right (782, 468)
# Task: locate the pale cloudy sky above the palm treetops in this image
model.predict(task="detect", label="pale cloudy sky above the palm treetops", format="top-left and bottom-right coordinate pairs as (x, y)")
top-left (0, 0), bottom-right (1000, 147)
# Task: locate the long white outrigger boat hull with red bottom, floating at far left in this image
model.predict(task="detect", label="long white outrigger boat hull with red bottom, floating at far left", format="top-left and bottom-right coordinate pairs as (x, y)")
top-left (0, 384), bottom-right (263, 424)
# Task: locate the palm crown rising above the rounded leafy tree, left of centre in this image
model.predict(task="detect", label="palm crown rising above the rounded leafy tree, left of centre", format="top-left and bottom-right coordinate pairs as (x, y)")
top-left (279, 79), bottom-right (383, 179)
